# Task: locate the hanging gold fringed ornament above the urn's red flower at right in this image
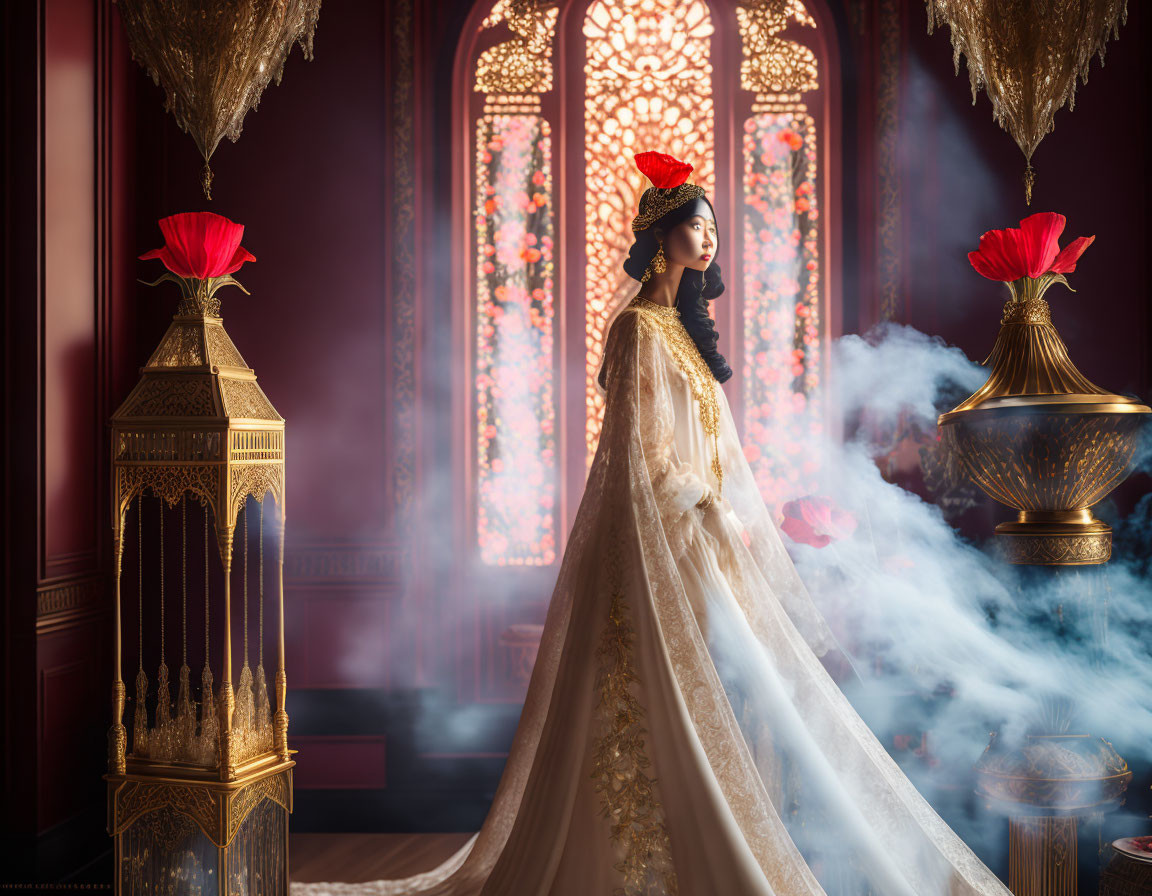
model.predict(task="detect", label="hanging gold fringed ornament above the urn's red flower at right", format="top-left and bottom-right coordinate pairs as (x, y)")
top-left (926, 0), bottom-right (1128, 204)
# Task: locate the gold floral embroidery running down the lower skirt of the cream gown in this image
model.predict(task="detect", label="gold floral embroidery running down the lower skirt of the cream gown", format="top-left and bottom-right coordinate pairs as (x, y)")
top-left (591, 582), bottom-right (680, 896)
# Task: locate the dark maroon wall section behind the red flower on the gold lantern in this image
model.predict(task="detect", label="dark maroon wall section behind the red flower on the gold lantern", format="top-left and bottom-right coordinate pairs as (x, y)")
top-left (136, 3), bottom-right (389, 544)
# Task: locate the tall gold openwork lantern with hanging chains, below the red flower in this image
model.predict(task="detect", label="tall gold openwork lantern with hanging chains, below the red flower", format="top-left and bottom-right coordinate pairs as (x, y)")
top-left (105, 271), bottom-right (295, 896)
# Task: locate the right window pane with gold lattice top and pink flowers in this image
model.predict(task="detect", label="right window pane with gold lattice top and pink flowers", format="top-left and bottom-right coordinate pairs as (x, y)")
top-left (737, 0), bottom-right (826, 507)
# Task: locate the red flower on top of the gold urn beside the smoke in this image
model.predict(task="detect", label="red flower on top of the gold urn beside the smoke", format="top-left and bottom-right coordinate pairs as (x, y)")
top-left (968, 212), bottom-right (1096, 302)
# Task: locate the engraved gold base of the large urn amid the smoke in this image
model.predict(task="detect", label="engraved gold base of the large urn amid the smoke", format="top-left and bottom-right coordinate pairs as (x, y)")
top-left (996, 510), bottom-right (1112, 567)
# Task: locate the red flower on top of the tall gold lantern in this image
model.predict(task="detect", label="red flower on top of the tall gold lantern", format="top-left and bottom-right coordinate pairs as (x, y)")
top-left (141, 212), bottom-right (256, 313)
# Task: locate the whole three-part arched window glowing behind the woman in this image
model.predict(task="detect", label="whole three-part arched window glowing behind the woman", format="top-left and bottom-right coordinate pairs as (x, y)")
top-left (455, 0), bottom-right (834, 565)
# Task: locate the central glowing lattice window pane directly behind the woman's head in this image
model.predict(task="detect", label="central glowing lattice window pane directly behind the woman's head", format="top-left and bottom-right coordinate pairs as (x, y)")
top-left (584, 0), bottom-right (714, 464)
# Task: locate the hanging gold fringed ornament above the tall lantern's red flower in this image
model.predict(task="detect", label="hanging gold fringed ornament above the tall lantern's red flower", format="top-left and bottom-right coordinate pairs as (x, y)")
top-left (118, 0), bottom-right (320, 199)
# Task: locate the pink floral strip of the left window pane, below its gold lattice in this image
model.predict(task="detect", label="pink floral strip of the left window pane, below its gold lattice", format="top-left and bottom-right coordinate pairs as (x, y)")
top-left (473, 113), bottom-right (559, 565)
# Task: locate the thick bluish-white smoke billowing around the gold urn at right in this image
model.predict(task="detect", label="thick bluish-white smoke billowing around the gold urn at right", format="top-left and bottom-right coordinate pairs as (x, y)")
top-left (785, 325), bottom-right (1152, 850)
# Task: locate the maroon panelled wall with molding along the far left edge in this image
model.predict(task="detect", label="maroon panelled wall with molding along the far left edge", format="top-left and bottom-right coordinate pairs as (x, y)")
top-left (0, 0), bottom-right (130, 866)
